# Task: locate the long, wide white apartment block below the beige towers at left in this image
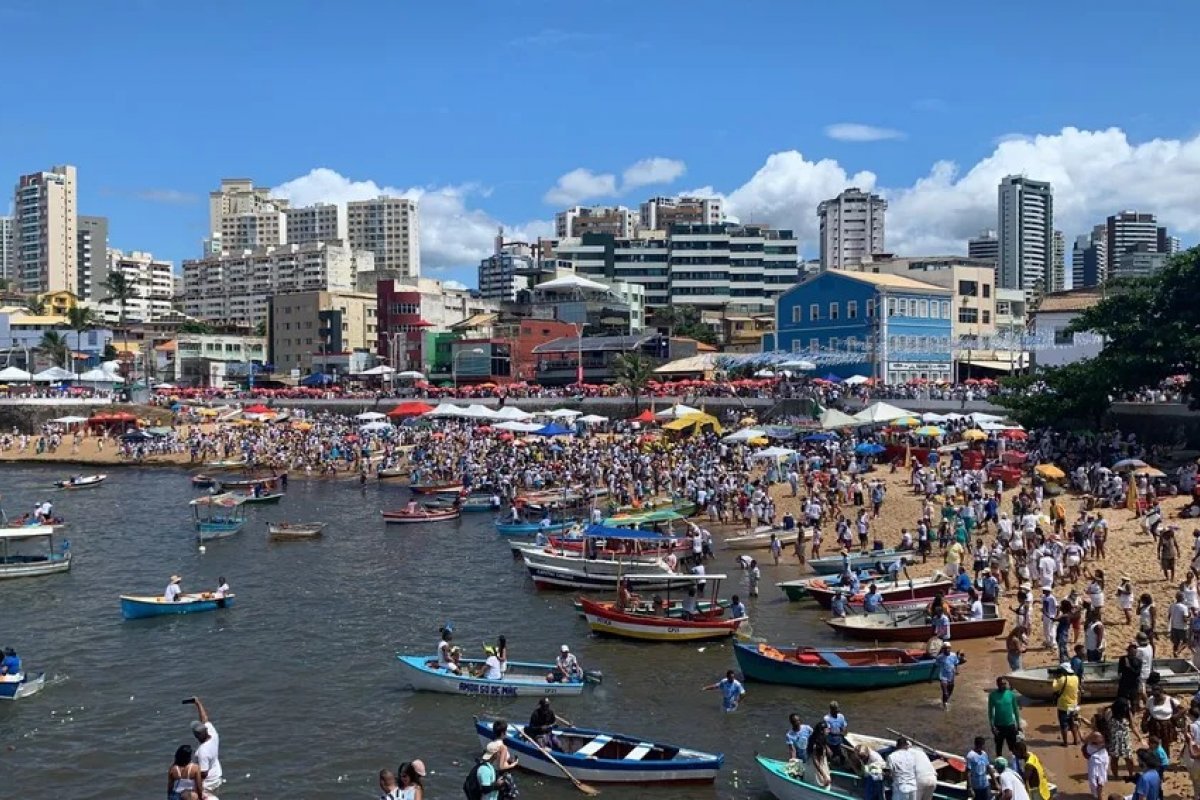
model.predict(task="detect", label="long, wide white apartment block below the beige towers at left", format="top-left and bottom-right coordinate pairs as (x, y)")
top-left (184, 242), bottom-right (374, 326)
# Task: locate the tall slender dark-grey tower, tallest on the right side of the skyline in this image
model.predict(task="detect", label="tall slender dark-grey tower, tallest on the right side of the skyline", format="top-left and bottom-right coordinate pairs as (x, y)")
top-left (996, 175), bottom-right (1054, 297)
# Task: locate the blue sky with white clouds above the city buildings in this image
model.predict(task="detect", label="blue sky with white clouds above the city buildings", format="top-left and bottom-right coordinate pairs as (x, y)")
top-left (0, 0), bottom-right (1200, 285)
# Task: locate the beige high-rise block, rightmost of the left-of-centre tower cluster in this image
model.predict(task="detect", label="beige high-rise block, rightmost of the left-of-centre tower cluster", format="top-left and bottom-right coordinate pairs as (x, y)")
top-left (346, 197), bottom-right (421, 278)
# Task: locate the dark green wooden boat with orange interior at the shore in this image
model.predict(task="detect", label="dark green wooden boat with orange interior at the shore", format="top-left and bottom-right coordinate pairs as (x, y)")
top-left (733, 643), bottom-right (937, 690)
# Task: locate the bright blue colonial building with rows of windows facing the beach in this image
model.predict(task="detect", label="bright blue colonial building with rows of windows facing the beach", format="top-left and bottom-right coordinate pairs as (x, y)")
top-left (763, 270), bottom-right (954, 384)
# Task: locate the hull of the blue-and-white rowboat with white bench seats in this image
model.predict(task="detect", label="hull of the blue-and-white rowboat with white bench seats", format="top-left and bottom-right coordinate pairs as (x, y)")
top-left (475, 720), bottom-right (725, 783)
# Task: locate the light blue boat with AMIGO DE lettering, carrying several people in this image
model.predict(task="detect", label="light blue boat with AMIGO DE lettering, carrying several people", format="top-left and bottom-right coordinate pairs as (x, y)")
top-left (396, 652), bottom-right (599, 697)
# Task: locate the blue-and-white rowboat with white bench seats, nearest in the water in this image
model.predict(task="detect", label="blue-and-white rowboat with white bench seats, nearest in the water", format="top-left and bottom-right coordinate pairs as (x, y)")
top-left (475, 720), bottom-right (725, 783)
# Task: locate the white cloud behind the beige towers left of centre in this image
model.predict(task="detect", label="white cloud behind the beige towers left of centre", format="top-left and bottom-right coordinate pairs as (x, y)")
top-left (271, 167), bottom-right (554, 271)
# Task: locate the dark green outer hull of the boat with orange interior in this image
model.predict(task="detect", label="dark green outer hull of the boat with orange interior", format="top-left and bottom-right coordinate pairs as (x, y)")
top-left (733, 643), bottom-right (937, 690)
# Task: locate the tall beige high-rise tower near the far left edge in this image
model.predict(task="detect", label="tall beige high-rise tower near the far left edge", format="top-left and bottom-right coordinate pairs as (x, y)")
top-left (13, 164), bottom-right (79, 294)
